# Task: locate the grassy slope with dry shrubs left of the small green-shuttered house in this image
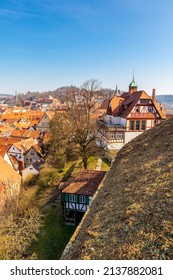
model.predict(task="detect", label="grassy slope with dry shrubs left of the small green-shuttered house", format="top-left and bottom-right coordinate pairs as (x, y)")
top-left (0, 157), bottom-right (109, 260)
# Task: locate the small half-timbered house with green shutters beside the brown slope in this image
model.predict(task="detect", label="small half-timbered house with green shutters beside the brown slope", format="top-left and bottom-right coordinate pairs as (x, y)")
top-left (59, 170), bottom-right (106, 225)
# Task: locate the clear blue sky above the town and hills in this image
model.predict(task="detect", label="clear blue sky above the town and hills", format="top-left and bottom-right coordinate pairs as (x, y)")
top-left (0, 0), bottom-right (173, 94)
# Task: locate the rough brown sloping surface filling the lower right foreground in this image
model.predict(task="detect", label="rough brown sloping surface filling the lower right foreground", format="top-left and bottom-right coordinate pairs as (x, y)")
top-left (61, 119), bottom-right (173, 260)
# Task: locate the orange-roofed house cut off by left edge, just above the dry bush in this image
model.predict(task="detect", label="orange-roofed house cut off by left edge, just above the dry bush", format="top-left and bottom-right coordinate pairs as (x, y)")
top-left (0, 156), bottom-right (22, 211)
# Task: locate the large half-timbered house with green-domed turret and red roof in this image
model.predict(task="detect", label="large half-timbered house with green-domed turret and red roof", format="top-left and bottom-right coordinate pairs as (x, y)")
top-left (97, 78), bottom-right (166, 150)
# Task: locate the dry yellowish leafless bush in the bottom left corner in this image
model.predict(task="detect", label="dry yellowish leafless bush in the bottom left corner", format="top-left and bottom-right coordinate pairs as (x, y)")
top-left (0, 187), bottom-right (42, 260)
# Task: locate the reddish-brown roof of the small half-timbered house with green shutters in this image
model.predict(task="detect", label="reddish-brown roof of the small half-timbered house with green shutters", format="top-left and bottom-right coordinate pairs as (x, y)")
top-left (61, 170), bottom-right (106, 196)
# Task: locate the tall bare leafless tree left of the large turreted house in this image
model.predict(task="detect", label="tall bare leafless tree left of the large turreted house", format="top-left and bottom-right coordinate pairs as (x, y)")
top-left (48, 79), bottom-right (101, 169)
